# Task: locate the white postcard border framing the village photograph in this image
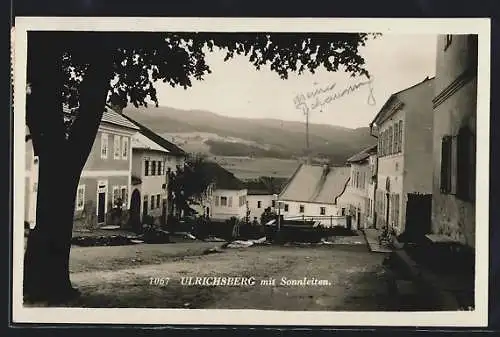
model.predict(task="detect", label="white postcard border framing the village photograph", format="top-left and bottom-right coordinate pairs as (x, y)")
top-left (12, 17), bottom-right (491, 327)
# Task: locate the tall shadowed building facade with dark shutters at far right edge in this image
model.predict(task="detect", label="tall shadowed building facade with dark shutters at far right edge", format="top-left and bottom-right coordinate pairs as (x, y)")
top-left (432, 35), bottom-right (478, 247)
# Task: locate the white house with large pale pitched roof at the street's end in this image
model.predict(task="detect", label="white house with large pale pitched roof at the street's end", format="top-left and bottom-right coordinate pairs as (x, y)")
top-left (278, 164), bottom-right (350, 227)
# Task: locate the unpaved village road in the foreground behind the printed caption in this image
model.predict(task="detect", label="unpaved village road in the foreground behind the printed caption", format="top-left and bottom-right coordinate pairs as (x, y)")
top-left (59, 245), bottom-right (402, 311)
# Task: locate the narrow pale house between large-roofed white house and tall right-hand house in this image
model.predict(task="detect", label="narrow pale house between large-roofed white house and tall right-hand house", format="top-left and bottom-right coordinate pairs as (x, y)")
top-left (339, 145), bottom-right (377, 229)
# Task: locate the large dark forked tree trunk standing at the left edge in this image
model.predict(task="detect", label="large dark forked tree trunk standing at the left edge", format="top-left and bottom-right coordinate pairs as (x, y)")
top-left (23, 33), bottom-right (112, 303)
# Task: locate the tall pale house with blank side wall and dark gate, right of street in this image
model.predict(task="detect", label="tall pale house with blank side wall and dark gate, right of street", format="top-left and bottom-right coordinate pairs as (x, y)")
top-left (370, 78), bottom-right (434, 235)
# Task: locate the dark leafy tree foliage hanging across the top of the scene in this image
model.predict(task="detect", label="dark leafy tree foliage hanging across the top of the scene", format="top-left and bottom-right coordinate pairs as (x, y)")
top-left (30, 32), bottom-right (378, 134)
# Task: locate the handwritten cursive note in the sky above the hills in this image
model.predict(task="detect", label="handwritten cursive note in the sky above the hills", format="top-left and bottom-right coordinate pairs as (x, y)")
top-left (293, 78), bottom-right (376, 114)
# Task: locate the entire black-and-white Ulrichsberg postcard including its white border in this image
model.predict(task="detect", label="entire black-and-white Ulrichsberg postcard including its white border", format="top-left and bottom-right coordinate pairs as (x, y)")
top-left (11, 17), bottom-right (490, 327)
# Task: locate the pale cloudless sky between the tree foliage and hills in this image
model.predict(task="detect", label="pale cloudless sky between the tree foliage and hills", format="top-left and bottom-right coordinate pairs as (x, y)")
top-left (156, 34), bottom-right (436, 128)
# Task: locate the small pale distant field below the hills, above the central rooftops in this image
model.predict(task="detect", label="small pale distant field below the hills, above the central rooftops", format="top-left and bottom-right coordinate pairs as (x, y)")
top-left (212, 156), bottom-right (299, 179)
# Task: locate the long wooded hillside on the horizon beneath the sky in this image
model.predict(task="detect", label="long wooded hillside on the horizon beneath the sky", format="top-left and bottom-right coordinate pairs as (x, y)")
top-left (124, 107), bottom-right (375, 163)
